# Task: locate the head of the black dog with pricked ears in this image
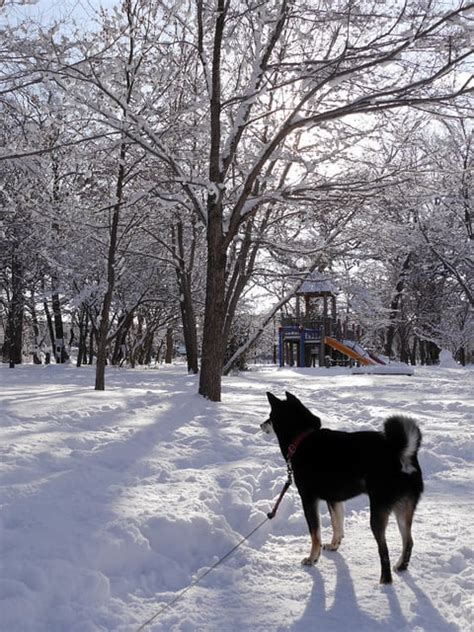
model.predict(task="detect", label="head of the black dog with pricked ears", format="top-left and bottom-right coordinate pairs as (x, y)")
top-left (260, 392), bottom-right (321, 439)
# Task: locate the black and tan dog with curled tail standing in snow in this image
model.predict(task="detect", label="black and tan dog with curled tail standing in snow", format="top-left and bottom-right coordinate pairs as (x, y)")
top-left (260, 392), bottom-right (423, 584)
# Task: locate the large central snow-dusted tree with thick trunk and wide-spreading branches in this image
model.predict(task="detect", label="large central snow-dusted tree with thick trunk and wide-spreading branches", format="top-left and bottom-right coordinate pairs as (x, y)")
top-left (1, 0), bottom-right (473, 400)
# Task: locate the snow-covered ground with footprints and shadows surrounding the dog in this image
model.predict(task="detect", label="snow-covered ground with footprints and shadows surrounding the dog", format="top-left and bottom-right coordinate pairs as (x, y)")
top-left (0, 366), bottom-right (474, 632)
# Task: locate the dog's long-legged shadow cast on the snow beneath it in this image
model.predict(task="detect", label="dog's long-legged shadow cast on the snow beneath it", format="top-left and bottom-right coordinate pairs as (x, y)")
top-left (291, 552), bottom-right (458, 632)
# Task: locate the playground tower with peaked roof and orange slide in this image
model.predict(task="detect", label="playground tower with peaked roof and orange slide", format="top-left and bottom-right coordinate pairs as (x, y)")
top-left (278, 271), bottom-right (385, 367)
